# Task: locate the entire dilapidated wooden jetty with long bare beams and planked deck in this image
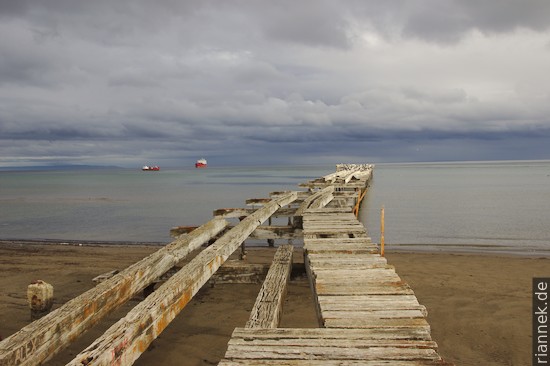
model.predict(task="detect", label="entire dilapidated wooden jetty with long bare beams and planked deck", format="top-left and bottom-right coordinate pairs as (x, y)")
top-left (0, 164), bottom-right (447, 366)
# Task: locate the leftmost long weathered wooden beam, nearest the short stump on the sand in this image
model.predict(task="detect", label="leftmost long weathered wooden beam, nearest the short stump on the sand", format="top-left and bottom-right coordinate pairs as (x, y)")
top-left (0, 219), bottom-right (228, 365)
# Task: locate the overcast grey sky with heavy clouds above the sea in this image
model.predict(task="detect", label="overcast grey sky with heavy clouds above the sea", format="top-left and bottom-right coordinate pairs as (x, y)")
top-left (0, 0), bottom-right (550, 167)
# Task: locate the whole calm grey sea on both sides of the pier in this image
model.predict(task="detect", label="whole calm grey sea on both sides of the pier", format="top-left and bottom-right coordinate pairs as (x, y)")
top-left (0, 161), bottom-right (550, 255)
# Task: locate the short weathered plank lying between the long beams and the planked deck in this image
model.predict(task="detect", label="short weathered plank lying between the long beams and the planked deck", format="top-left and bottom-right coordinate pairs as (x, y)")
top-left (246, 245), bottom-right (294, 328)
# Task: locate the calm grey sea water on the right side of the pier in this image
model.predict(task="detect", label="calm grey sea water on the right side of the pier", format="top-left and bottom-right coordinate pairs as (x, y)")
top-left (363, 161), bottom-right (550, 255)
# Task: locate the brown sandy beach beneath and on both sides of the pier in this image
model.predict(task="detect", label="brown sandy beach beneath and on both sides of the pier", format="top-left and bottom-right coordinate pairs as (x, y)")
top-left (0, 242), bottom-right (550, 365)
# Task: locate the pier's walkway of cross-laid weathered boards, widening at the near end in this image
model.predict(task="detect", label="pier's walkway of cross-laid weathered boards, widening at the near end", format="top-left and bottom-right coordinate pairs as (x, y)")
top-left (219, 189), bottom-right (447, 366)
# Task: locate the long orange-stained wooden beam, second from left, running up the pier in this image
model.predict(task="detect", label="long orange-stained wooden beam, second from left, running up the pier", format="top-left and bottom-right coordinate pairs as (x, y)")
top-left (68, 192), bottom-right (296, 366)
